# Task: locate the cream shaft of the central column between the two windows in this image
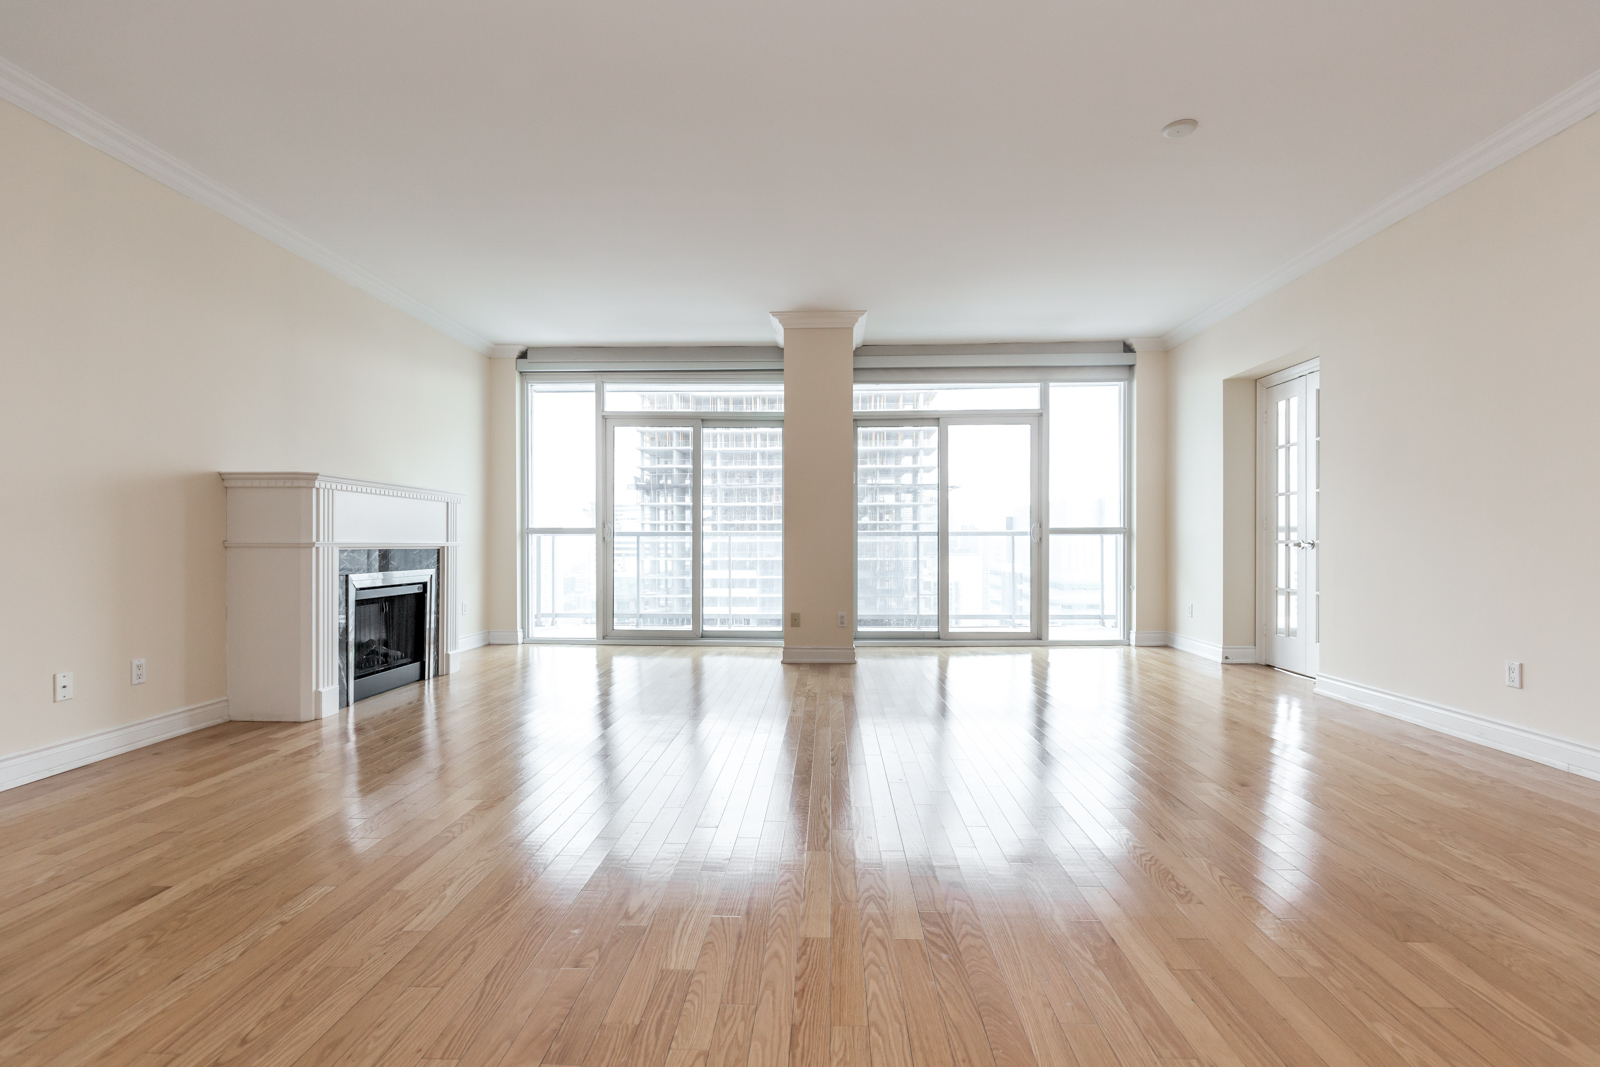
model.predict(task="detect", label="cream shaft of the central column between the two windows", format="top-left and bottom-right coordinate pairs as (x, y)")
top-left (784, 326), bottom-right (856, 649)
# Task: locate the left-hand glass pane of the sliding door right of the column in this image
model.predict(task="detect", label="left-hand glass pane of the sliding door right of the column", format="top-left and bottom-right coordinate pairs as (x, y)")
top-left (856, 426), bottom-right (939, 633)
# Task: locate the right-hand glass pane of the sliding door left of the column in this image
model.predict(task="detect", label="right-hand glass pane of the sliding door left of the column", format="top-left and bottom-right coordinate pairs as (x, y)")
top-left (701, 426), bottom-right (784, 632)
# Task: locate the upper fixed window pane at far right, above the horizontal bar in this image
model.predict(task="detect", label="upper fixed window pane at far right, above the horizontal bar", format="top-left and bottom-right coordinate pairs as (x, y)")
top-left (1050, 382), bottom-right (1125, 528)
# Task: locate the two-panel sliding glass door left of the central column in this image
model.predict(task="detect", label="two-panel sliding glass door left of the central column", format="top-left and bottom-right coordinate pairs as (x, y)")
top-left (598, 414), bottom-right (782, 640)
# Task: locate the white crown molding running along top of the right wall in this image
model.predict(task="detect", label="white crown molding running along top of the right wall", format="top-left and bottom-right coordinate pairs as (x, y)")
top-left (1162, 70), bottom-right (1600, 349)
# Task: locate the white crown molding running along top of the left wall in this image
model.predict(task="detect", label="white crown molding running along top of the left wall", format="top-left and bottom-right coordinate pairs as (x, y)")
top-left (0, 58), bottom-right (491, 354)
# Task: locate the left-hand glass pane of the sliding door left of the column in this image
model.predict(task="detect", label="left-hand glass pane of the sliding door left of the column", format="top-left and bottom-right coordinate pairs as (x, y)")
top-left (611, 426), bottom-right (694, 630)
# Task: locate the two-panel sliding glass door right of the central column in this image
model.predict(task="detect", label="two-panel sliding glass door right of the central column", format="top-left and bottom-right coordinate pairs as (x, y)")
top-left (856, 414), bottom-right (1045, 640)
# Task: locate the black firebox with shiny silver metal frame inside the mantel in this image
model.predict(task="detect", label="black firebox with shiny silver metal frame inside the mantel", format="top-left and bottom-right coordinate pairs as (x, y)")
top-left (346, 569), bottom-right (435, 704)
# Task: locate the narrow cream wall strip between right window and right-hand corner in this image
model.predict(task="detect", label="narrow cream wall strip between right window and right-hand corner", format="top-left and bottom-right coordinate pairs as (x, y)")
top-left (1133, 352), bottom-right (1171, 635)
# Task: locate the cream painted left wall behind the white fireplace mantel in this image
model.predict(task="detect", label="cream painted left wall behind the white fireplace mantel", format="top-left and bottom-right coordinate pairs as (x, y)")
top-left (0, 95), bottom-right (486, 755)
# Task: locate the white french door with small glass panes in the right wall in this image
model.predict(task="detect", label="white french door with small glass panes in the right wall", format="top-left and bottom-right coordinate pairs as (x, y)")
top-left (1259, 368), bottom-right (1322, 675)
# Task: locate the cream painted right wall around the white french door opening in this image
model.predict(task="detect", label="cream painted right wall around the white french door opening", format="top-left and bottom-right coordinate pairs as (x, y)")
top-left (1171, 106), bottom-right (1600, 745)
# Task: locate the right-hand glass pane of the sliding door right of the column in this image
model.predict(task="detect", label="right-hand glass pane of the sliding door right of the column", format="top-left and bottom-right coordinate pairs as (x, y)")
top-left (946, 426), bottom-right (1034, 633)
